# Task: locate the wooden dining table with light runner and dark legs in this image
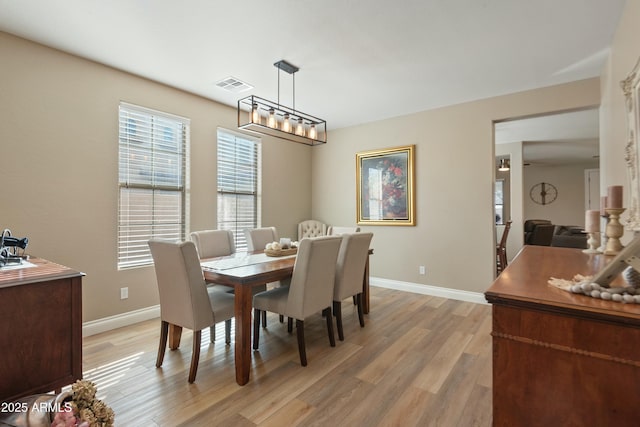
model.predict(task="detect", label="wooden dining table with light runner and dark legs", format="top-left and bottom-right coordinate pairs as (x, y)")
top-left (195, 249), bottom-right (373, 385)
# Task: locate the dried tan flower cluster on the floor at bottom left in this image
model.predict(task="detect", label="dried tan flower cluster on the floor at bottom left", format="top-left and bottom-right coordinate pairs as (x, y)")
top-left (51, 380), bottom-right (115, 427)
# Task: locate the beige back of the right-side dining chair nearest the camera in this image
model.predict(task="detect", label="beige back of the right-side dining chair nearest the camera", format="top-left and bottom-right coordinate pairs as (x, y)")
top-left (283, 236), bottom-right (342, 320)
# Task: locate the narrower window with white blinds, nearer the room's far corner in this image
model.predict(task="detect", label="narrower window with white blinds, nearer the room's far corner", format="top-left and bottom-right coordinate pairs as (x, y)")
top-left (218, 129), bottom-right (260, 250)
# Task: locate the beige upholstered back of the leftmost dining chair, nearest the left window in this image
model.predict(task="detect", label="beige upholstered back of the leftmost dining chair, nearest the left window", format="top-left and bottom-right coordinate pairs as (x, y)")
top-left (149, 240), bottom-right (214, 331)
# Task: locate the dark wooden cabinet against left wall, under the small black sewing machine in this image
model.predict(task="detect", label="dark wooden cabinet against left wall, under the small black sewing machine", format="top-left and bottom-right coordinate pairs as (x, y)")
top-left (0, 258), bottom-right (84, 402)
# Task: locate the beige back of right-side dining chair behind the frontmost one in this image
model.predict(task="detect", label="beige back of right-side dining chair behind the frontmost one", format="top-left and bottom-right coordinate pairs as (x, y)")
top-left (333, 233), bottom-right (373, 301)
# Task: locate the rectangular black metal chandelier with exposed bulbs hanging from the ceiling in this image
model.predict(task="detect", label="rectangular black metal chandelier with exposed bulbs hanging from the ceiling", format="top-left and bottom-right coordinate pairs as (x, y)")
top-left (238, 60), bottom-right (327, 146)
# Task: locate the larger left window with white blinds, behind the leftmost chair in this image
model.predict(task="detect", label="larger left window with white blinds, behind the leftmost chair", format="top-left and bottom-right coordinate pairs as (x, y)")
top-left (118, 103), bottom-right (189, 269)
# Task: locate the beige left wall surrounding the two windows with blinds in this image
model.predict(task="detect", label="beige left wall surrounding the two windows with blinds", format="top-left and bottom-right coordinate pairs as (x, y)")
top-left (0, 33), bottom-right (311, 321)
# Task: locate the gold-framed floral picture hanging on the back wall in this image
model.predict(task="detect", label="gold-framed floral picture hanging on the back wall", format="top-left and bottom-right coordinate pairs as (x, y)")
top-left (356, 145), bottom-right (415, 225)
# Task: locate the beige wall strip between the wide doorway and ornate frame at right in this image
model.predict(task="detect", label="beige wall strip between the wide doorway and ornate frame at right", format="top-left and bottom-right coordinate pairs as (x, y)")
top-left (600, 1), bottom-right (640, 242)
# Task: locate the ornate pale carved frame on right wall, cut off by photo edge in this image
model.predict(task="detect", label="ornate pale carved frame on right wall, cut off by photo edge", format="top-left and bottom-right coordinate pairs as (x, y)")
top-left (620, 58), bottom-right (640, 231)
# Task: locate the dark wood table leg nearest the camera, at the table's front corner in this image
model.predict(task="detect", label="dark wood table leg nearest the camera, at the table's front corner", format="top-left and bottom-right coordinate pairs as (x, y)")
top-left (235, 286), bottom-right (253, 385)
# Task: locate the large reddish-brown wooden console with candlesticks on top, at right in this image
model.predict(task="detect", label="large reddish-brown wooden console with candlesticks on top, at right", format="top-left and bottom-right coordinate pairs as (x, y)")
top-left (485, 246), bottom-right (640, 427)
